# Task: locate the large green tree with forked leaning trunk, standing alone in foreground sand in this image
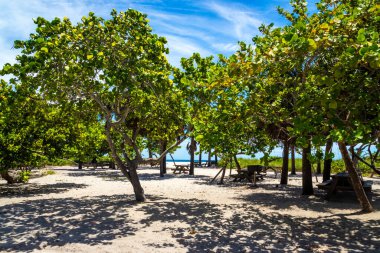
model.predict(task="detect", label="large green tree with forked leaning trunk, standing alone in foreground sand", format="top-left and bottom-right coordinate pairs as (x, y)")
top-left (4, 9), bottom-right (184, 201)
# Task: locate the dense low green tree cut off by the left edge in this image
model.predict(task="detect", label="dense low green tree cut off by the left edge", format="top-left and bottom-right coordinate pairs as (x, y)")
top-left (0, 80), bottom-right (74, 183)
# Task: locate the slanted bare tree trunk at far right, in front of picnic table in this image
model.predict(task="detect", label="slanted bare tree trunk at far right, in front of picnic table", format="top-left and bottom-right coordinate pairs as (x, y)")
top-left (338, 141), bottom-right (374, 212)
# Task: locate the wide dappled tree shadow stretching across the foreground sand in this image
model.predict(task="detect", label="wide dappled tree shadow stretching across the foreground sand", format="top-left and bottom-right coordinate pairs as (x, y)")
top-left (0, 192), bottom-right (380, 252)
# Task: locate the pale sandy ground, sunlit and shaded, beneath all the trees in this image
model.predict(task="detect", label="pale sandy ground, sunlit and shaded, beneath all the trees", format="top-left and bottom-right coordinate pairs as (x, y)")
top-left (0, 163), bottom-right (380, 253)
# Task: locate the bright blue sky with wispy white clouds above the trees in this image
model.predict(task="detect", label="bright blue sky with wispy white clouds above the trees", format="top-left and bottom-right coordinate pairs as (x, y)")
top-left (0, 0), bottom-right (328, 159)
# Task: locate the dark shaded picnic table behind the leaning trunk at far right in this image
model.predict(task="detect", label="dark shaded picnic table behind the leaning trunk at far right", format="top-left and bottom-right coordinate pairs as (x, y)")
top-left (317, 172), bottom-right (373, 199)
